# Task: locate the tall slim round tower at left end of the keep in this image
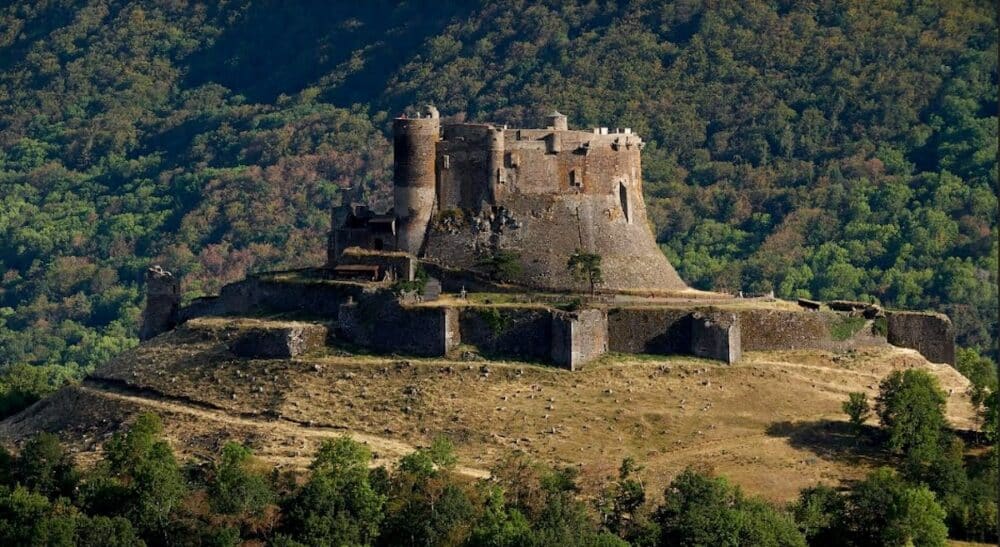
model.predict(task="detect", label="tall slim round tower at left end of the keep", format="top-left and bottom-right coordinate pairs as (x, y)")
top-left (392, 106), bottom-right (441, 254)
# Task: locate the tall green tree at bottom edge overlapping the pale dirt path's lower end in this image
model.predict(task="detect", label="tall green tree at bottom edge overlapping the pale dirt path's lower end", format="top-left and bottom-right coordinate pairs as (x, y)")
top-left (281, 437), bottom-right (385, 545)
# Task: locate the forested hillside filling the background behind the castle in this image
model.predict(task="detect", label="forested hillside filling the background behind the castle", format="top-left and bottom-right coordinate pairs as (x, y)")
top-left (0, 0), bottom-right (998, 411)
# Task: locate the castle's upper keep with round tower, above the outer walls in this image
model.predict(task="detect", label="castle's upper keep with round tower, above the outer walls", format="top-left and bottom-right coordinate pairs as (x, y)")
top-left (329, 106), bottom-right (687, 292)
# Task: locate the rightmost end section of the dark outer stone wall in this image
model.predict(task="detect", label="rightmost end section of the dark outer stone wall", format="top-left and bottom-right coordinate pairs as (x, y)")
top-left (886, 312), bottom-right (955, 365)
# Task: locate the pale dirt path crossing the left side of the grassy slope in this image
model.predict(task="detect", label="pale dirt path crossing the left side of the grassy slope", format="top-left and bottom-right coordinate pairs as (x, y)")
top-left (77, 384), bottom-right (489, 479)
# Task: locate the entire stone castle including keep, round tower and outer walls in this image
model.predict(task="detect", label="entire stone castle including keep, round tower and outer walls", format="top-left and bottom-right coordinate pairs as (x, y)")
top-left (141, 107), bottom-right (955, 370)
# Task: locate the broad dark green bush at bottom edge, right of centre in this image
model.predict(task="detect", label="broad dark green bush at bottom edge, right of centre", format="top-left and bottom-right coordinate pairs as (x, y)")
top-left (654, 469), bottom-right (806, 546)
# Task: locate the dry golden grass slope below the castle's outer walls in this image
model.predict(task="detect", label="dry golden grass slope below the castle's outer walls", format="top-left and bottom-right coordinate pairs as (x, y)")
top-left (0, 320), bottom-right (974, 506)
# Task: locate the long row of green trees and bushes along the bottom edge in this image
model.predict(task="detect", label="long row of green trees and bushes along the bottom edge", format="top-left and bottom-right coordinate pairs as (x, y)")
top-left (0, 415), bottom-right (997, 547)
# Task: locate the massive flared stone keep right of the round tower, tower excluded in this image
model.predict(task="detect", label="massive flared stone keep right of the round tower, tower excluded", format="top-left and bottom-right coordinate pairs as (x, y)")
top-left (423, 119), bottom-right (687, 291)
